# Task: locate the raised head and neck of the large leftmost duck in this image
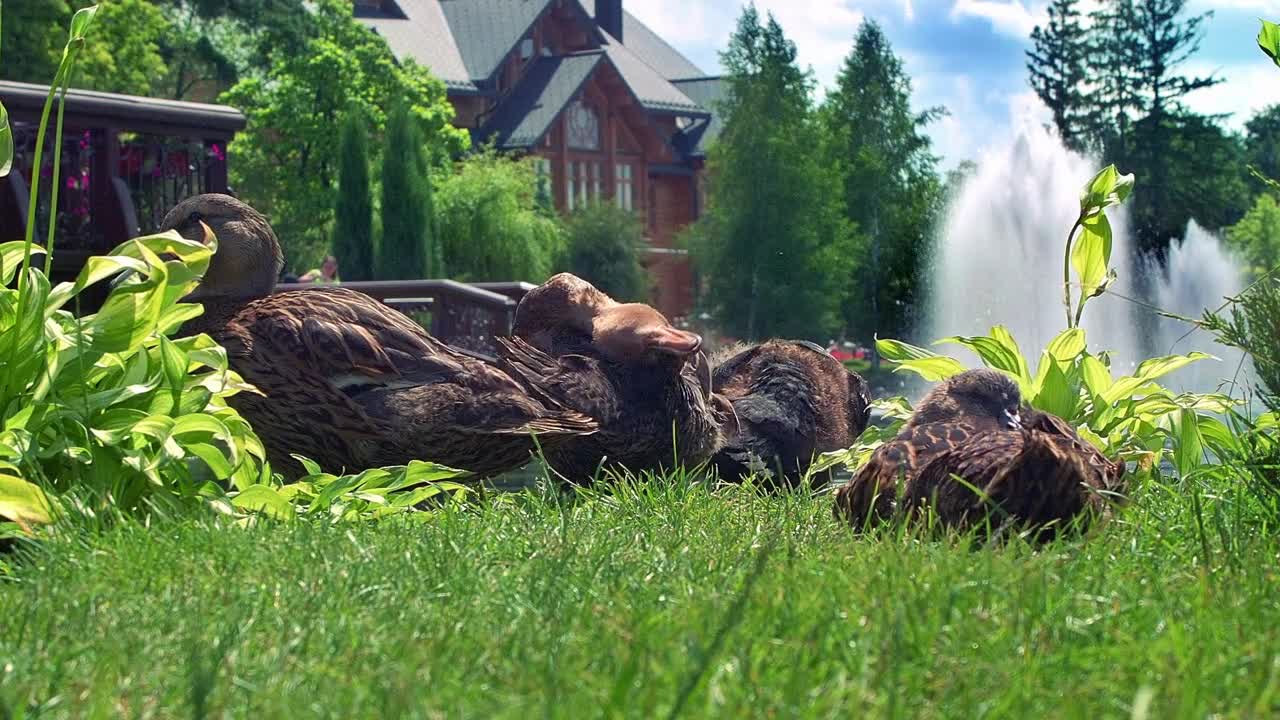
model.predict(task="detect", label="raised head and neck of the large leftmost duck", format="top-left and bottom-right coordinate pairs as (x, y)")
top-left (160, 193), bottom-right (284, 299)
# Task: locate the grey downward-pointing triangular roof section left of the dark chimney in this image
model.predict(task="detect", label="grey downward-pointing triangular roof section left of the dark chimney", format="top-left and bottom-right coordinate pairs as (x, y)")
top-left (439, 0), bottom-right (552, 81)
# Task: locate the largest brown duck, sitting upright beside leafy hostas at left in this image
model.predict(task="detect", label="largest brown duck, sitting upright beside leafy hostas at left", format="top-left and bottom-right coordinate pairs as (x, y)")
top-left (161, 193), bottom-right (596, 479)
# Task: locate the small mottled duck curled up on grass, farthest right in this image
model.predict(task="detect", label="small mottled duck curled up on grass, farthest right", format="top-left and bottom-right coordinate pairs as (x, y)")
top-left (835, 369), bottom-right (1125, 541)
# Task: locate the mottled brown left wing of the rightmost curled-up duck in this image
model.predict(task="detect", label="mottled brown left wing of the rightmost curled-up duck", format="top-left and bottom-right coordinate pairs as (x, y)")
top-left (835, 420), bottom-right (980, 528)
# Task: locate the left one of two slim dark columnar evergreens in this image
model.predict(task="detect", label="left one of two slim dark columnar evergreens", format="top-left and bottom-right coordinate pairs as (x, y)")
top-left (333, 111), bottom-right (374, 281)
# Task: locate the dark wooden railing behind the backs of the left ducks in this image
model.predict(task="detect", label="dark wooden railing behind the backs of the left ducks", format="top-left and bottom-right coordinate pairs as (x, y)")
top-left (275, 281), bottom-right (535, 357)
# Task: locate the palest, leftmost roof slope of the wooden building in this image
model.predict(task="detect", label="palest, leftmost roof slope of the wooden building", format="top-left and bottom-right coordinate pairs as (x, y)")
top-left (357, 0), bottom-right (478, 91)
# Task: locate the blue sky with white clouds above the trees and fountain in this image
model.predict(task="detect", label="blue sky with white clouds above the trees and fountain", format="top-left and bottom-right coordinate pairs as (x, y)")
top-left (623, 0), bottom-right (1280, 168)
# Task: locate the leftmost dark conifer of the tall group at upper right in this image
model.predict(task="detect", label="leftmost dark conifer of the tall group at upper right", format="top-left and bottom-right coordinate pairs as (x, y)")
top-left (1027, 0), bottom-right (1089, 151)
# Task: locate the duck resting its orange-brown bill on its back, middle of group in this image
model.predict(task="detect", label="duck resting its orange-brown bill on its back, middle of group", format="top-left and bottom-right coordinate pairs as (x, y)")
top-left (499, 273), bottom-right (726, 486)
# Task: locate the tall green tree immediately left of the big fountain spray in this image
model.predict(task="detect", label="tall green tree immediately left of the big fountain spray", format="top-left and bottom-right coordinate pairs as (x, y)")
top-left (822, 20), bottom-right (943, 345)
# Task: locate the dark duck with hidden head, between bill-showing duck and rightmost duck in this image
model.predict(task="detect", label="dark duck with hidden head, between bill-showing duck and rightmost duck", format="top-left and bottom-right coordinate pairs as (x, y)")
top-left (712, 340), bottom-right (870, 487)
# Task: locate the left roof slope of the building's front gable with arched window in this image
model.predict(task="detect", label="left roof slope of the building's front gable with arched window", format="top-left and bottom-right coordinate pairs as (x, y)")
top-left (480, 50), bottom-right (605, 150)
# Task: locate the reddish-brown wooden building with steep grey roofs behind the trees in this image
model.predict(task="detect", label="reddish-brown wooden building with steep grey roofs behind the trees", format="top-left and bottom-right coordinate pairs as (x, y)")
top-left (353, 0), bottom-right (721, 318)
